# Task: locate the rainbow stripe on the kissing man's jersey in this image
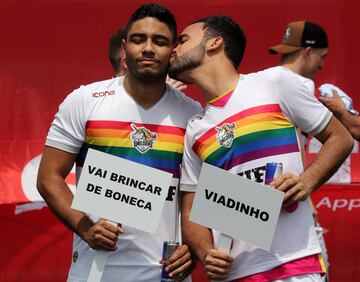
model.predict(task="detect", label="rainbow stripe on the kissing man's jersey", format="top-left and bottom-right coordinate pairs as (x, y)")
top-left (192, 104), bottom-right (299, 170)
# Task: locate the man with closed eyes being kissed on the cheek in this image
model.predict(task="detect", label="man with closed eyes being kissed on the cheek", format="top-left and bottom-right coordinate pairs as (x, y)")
top-left (37, 4), bottom-right (201, 282)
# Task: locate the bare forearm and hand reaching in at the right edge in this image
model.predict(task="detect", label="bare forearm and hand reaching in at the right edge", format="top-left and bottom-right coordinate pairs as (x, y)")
top-left (318, 90), bottom-right (360, 141)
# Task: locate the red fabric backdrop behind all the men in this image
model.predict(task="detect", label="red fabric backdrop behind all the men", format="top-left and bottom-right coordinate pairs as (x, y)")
top-left (0, 0), bottom-right (360, 281)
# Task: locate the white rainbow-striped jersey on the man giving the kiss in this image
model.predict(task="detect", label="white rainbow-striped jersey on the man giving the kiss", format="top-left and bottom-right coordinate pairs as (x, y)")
top-left (180, 67), bottom-right (332, 280)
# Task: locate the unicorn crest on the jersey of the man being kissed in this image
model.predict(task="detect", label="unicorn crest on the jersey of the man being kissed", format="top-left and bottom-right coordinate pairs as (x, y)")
top-left (130, 123), bottom-right (157, 154)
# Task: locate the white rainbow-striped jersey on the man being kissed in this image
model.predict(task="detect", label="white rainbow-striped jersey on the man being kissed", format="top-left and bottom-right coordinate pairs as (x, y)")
top-left (46, 78), bottom-right (201, 282)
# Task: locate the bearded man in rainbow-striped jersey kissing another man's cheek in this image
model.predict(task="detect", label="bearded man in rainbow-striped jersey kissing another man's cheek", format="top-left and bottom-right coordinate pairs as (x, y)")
top-left (169, 16), bottom-right (353, 282)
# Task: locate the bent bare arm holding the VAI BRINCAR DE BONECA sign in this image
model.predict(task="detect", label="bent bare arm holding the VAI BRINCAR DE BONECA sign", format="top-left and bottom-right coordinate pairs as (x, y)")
top-left (37, 146), bottom-right (122, 251)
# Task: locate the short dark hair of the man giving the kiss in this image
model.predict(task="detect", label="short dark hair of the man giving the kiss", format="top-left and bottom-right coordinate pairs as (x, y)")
top-left (194, 15), bottom-right (246, 69)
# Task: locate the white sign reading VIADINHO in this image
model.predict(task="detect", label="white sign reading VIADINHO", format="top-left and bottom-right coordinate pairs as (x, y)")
top-left (190, 163), bottom-right (284, 251)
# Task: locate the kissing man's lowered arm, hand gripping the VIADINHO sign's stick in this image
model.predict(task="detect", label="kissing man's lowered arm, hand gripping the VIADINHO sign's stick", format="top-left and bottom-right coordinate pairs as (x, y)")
top-left (181, 192), bottom-right (233, 280)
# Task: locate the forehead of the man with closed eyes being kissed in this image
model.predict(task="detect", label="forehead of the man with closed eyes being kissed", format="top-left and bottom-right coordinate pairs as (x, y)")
top-left (128, 17), bottom-right (172, 39)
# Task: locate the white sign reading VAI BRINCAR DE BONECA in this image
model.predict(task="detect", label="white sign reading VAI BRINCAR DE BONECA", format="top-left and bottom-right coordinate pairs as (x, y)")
top-left (71, 149), bottom-right (172, 233)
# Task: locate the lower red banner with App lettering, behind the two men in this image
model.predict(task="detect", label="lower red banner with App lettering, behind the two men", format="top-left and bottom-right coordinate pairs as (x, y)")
top-left (0, 185), bottom-right (360, 282)
